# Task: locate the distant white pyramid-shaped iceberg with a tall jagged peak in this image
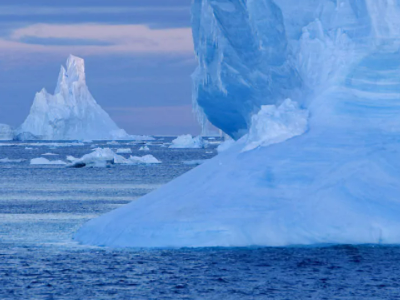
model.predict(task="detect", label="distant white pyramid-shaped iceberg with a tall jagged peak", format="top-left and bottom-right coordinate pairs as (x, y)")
top-left (17, 55), bottom-right (127, 140)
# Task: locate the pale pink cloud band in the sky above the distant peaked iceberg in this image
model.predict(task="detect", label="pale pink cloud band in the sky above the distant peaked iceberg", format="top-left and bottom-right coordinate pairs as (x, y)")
top-left (0, 24), bottom-right (193, 55)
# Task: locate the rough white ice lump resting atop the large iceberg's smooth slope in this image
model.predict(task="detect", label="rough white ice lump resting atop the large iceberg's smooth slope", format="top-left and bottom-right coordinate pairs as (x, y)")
top-left (243, 99), bottom-right (308, 151)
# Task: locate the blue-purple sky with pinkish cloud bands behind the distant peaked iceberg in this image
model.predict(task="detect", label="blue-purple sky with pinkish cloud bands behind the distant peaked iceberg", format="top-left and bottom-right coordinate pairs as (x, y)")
top-left (0, 0), bottom-right (200, 135)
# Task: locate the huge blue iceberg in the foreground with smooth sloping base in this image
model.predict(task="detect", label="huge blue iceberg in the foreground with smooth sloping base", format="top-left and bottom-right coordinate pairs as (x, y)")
top-left (76, 0), bottom-right (400, 247)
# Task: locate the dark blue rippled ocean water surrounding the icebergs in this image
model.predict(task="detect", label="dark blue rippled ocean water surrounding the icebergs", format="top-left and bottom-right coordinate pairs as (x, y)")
top-left (0, 138), bottom-right (400, 299)
